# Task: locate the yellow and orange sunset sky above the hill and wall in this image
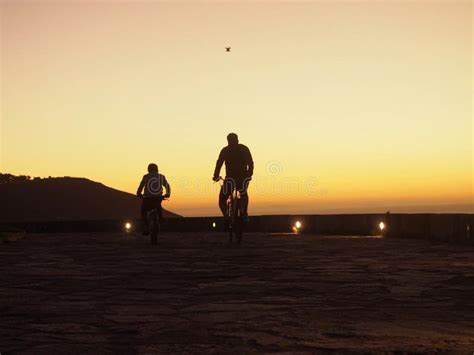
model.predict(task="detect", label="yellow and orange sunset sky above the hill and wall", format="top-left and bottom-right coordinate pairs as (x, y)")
top-left (0, 0), bottom-right (474, 216)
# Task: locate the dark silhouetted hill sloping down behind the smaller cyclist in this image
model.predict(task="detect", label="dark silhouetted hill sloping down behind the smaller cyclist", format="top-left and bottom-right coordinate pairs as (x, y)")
top-left (0, 175), bottom-right (179, 222)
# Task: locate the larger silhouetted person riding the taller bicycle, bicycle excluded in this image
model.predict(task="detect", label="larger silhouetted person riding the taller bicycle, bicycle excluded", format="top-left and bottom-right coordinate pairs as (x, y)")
top-left (212, 133), bottom-right (253, 225)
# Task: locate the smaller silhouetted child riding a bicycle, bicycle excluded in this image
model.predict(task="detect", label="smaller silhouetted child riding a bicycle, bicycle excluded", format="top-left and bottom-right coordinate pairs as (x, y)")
top-left (137, 163), bottom-right (171, 235)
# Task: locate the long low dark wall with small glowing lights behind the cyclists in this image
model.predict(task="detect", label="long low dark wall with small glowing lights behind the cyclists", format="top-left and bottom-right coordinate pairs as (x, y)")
top-left (0, 214), bottom-right (474, 243)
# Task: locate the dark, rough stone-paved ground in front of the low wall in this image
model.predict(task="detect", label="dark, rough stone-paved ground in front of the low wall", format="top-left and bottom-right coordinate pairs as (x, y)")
top-left (0, 234), bottom-right (474, 354)
